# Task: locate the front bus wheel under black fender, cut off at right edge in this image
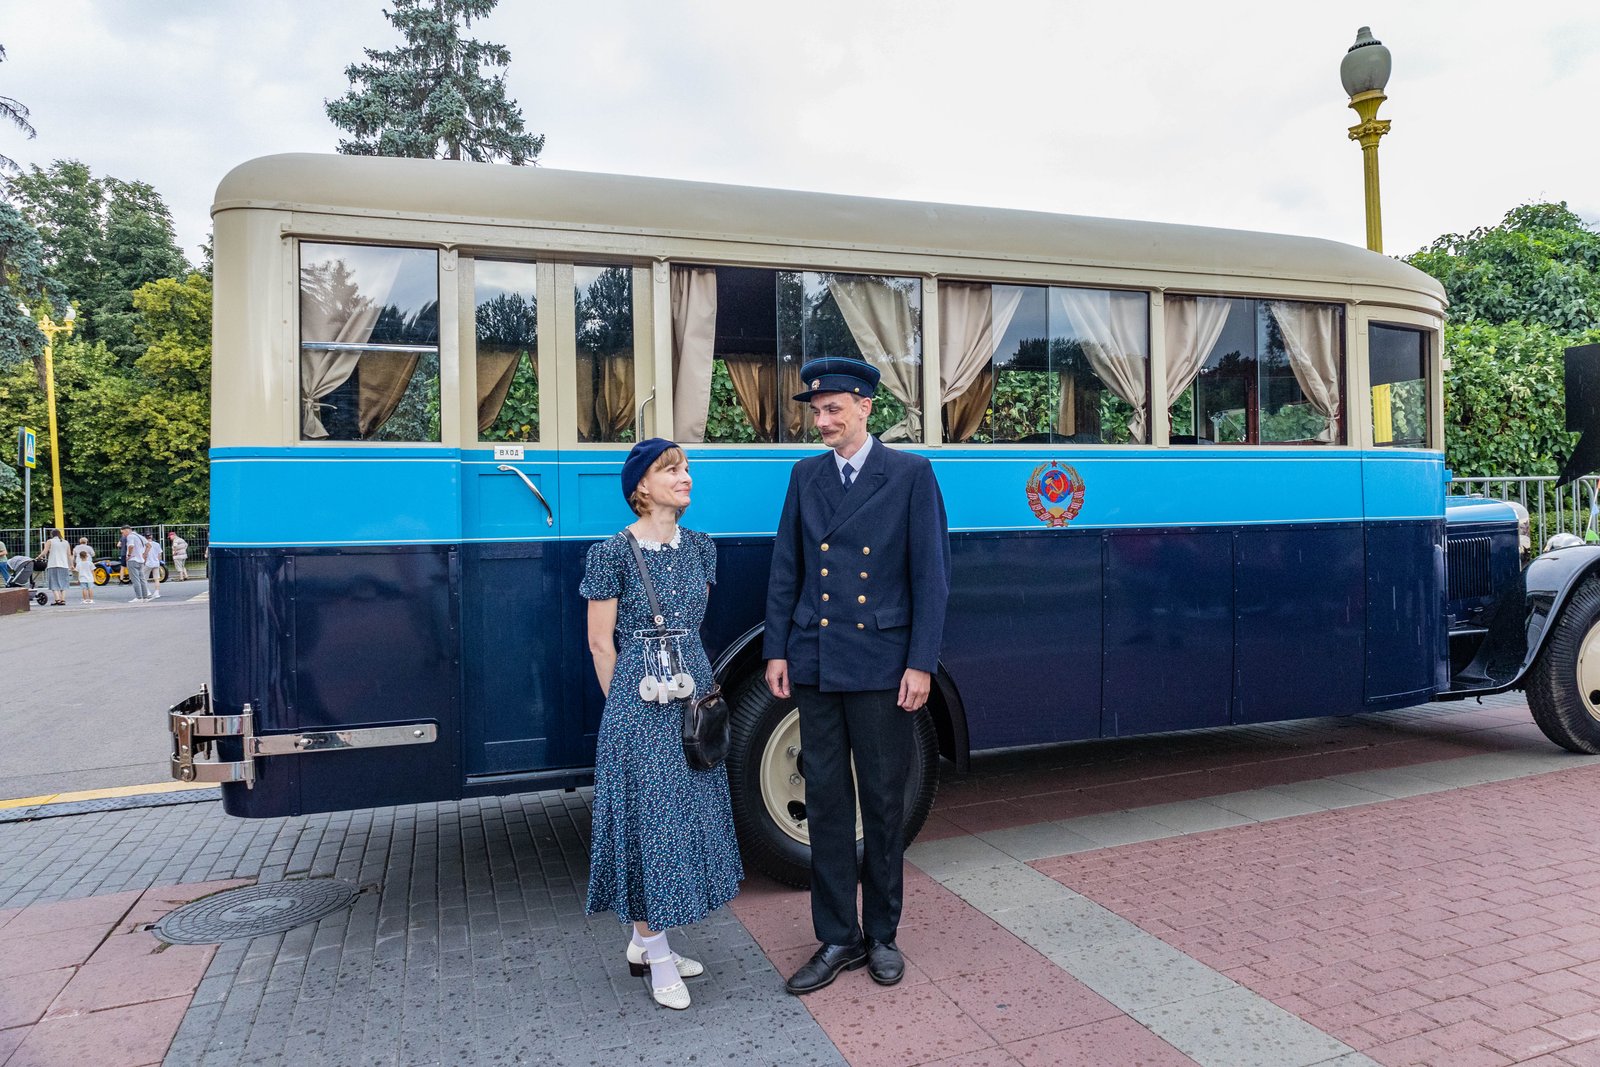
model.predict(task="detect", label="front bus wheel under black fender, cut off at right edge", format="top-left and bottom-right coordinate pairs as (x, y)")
top-left (1528, 577), bottom-right (1600, 753)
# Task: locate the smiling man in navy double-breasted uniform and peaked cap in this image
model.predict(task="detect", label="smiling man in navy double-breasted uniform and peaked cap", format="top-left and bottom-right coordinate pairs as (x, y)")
top-left (762, 357), bottom-right (950, 995)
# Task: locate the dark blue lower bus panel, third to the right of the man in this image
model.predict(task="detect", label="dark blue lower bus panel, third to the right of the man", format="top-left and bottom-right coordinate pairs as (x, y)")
top-left (1234, 526), bottom-right (1366, 723)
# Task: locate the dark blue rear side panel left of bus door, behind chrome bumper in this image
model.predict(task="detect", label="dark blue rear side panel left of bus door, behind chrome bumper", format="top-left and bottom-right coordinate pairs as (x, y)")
top-left (224, 545), bottom-right (461, 816)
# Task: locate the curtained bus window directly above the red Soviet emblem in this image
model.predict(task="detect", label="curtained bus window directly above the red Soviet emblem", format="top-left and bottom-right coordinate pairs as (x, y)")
top-left (939, 282), bottom-right (1150, 445)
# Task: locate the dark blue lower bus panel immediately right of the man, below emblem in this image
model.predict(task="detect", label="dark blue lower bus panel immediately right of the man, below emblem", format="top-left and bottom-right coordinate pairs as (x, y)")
top-left (942, 530), bottom-right (1101, 750)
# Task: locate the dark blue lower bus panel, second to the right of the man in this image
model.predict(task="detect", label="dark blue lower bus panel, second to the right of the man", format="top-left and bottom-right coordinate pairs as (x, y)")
top-left (1104, 528), bottom-right (1234, 736)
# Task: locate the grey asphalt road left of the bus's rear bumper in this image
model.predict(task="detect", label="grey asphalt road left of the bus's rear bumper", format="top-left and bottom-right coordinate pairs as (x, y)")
top-left (0, 579), bottom-right (211, 800)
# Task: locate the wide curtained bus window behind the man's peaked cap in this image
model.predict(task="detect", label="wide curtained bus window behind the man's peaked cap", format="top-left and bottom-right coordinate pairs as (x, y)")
top-left (672, 267), bottom-right (922, 442)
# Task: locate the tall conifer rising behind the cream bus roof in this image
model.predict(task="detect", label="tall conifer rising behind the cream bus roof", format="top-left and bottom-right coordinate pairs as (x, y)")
top-left (325, 0), bottom-right (544, 165)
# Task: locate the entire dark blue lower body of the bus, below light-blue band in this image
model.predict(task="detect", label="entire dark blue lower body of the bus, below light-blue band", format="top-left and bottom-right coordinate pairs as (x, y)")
top-left (211, 522), bottom-right (1448, 816)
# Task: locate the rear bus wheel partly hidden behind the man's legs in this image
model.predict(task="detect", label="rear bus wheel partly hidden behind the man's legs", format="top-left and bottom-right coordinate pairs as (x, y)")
top-left (728, 677), bottom-right (939, 889)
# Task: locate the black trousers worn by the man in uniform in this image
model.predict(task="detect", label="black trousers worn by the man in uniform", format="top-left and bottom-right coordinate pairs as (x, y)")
top-left (794, 685), bottom-right (912, 945)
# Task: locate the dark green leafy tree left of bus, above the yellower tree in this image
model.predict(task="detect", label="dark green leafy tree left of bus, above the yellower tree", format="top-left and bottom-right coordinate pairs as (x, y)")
top-left (6, 160), bottom-right (189, 365)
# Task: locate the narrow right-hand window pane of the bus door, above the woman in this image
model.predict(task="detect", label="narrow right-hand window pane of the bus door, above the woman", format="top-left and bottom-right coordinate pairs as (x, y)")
top-left (573, 267), bottom-right (635, 442)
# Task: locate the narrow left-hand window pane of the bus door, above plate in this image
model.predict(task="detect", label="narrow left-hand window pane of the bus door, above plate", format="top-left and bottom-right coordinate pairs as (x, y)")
top-left (472, 259), bottom-right (539, 442)
